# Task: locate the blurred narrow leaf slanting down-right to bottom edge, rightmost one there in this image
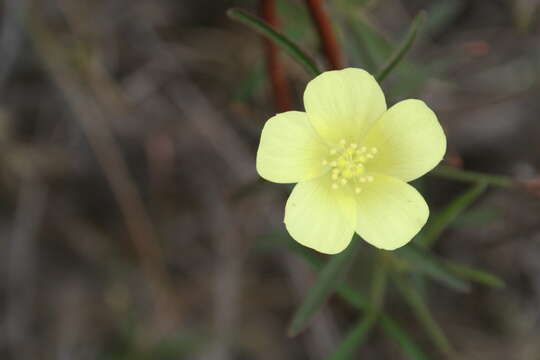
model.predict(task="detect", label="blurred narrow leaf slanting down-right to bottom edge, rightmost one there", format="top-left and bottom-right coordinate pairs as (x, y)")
top-left (394, 276), bottom-right (454, 355)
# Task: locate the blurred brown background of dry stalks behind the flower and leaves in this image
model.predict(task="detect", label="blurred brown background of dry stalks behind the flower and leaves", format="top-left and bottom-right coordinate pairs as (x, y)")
top-left (0, 0), bottom-right (540, 360)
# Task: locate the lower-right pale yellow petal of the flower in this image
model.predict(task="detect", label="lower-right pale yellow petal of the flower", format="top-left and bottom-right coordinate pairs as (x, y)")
top-left (356, 174), bottom-right (429, 250)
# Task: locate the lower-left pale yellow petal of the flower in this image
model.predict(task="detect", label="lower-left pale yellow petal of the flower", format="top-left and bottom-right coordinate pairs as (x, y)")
top-left (285, 176), bottom-right (356, 254)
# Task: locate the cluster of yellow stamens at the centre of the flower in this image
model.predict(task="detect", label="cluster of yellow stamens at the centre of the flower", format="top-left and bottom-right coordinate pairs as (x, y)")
top-left (322, 139), bottom-right (378, 194)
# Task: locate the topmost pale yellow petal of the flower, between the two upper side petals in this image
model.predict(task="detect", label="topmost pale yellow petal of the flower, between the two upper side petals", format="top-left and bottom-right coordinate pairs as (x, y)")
top-left (304, 68), bottom-right (386, 145)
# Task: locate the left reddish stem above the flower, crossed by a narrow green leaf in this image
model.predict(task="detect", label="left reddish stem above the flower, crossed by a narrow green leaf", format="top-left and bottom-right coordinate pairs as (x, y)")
top-left (261, 0), bottom-right (291, 111)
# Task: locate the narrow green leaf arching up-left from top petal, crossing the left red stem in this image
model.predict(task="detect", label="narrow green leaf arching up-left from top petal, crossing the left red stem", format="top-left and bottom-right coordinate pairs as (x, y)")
top-left (227, 9), bottom-right (321, 76)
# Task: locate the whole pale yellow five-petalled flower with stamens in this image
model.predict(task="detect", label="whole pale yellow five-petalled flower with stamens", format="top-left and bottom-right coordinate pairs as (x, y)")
top-left (257, 68), bottom-right (446, 254)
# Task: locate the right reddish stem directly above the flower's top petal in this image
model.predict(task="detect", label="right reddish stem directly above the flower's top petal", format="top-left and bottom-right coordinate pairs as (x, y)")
top-left (306, 0), bottom-right (343, 69)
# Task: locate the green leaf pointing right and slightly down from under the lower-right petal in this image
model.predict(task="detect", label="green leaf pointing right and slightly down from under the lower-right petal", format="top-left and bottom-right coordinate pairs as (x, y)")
top-left (396, 244), bottom-right (470, 292)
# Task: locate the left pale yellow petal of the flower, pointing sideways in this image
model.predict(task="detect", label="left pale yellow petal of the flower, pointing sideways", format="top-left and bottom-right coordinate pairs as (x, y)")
top-left (257, 111), bottom-right (328, 183)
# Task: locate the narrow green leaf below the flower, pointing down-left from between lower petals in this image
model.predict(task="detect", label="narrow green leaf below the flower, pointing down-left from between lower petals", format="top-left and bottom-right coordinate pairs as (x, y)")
top-left (288, 239), bottom-right (360, 336)
